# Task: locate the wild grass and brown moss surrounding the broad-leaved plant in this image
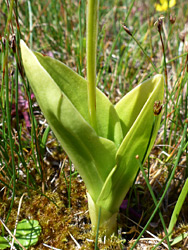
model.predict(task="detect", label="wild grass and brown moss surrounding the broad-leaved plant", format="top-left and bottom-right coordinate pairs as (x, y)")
top-left (0, 0), bottom-right (188, 249)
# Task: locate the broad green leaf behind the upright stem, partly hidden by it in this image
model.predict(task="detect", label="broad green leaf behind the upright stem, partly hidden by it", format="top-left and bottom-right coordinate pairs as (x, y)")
top-left (35, 53), bottom-right (123, 146)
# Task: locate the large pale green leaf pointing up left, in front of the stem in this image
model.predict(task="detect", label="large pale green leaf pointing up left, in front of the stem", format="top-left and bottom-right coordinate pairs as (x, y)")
top-left (21, 43), bottom-right (117, 200)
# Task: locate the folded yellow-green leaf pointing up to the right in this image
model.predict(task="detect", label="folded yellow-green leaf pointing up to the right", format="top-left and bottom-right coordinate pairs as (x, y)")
top-left (97, 75), bottom-right (164, 212)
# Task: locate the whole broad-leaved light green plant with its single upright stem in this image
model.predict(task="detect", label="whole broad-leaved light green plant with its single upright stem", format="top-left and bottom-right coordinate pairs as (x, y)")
top-left (20, 0), bottom-right (164, 236)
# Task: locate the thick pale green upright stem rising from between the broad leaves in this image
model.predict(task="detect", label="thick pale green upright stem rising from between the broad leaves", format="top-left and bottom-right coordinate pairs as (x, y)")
top-left (86, 0), bottom-right (99, 130)
